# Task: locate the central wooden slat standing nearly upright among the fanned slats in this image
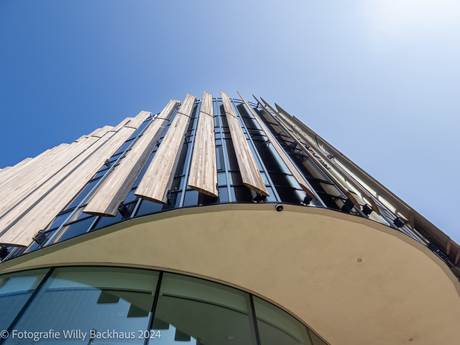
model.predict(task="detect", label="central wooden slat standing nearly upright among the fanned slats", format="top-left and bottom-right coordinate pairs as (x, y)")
top-left (188, 92), bottom-right (218, 197)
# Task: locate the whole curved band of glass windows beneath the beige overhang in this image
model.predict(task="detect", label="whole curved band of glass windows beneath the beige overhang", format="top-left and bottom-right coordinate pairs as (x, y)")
top-left (0, 267), bottom-right (326, 345)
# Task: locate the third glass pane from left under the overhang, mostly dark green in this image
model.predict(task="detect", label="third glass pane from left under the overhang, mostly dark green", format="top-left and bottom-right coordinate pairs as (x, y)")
top-left (152, 273), bottom-right (256, 345)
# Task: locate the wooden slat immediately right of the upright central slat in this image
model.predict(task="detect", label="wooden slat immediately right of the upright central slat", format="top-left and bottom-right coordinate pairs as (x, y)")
top-left (220, 91), bottom-right (269, 196)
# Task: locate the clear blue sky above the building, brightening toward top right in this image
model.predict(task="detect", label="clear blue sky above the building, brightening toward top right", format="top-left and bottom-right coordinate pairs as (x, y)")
top-left (0, 0), bottom-right (460, 242)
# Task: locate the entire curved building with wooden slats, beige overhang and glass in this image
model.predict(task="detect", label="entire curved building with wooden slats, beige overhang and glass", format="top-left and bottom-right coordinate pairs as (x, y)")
top-left (0, 92), bottom-right (460, 345)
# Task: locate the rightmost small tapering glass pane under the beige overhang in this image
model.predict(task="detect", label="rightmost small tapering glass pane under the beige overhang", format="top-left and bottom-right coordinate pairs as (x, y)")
top-left (253, 297), bottom-right (314, 345)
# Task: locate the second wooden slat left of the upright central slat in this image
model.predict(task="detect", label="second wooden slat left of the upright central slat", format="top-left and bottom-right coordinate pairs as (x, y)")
top-left (83, 100), bottom-right (180, 216)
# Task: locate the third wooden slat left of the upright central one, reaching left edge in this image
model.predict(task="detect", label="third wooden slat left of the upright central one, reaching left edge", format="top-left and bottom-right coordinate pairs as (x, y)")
top-left (0, 123), bottom-right (139, 246)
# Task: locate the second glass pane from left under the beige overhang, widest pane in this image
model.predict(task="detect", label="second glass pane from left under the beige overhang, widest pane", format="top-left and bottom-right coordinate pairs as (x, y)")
top-left (6, 267), bottom-right (158, 345)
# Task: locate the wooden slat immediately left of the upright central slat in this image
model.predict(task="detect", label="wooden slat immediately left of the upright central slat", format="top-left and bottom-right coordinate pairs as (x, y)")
top-left (134, 94), bottom-right (196, 203)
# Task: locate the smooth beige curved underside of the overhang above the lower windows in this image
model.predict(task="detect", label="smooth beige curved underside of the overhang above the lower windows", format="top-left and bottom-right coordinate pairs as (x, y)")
top-left (0, 204), bottom-right (460, 345)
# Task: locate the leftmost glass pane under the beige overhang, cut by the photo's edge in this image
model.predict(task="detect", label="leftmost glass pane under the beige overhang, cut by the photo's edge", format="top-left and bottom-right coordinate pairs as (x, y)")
top-left (0, 269), bottom-right (48, 330)
